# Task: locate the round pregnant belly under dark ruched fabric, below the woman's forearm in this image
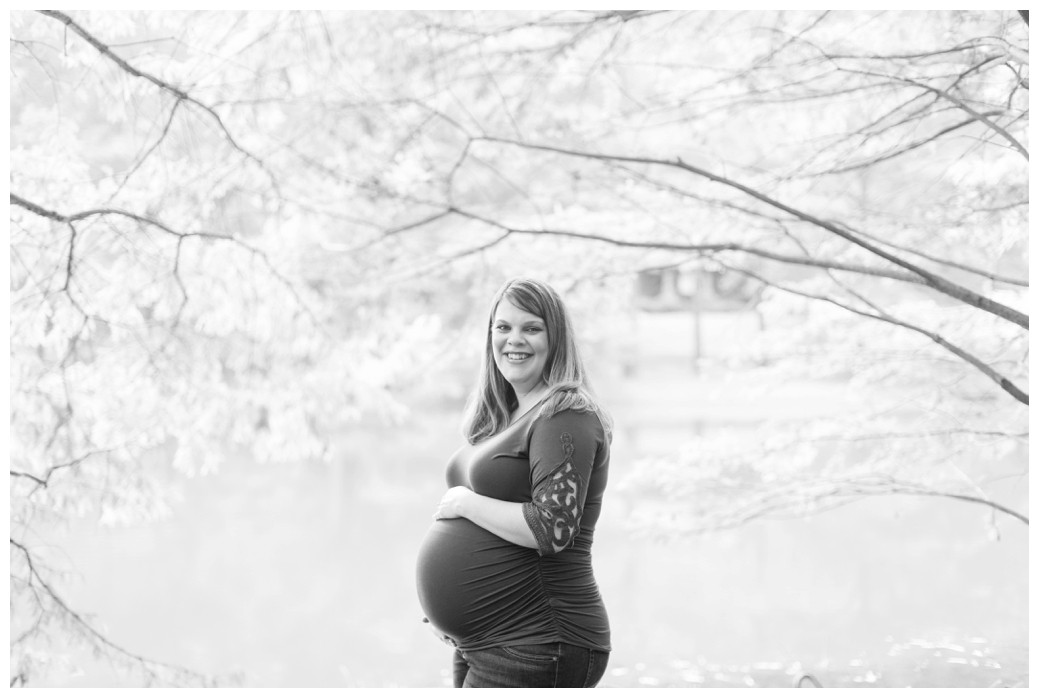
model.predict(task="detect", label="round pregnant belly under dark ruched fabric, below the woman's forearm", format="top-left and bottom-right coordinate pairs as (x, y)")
top-left (417, 518), bottom-right (543, 645)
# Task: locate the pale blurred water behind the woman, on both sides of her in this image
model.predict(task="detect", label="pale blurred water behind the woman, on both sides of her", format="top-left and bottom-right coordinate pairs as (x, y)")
top-left (36, 315), bottom-right (1028, 687)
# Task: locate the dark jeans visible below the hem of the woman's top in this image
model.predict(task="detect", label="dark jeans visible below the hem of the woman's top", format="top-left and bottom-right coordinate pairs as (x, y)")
top-left (453, 642), bottom-right (610, 689)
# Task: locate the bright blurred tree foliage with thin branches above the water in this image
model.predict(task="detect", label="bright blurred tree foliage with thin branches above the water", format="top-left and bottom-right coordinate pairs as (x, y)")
top-left (10, 10), bottom-right (1028, 684)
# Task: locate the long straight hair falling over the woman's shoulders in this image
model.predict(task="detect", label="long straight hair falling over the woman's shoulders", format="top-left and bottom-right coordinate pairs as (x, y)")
top-left (462, 277), bottom-right (613, 444)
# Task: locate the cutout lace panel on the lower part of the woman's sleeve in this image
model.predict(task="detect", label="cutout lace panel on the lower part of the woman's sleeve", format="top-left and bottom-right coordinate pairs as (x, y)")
top-left (523, 432), bottom-right (585, 555)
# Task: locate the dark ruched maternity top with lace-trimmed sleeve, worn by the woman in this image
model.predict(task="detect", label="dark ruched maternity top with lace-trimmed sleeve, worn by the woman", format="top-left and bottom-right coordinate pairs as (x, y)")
top-left (417, 407), bottom-right (610, 651)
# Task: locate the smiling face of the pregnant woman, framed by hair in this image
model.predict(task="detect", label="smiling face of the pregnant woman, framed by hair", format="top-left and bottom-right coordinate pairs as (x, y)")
top-left (490, 298), bottom-right (549, 394)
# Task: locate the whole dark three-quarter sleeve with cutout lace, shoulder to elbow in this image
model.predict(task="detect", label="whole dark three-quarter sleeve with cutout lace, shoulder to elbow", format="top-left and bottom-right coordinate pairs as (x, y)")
top-left (523, 410), bottom-right (602, 556)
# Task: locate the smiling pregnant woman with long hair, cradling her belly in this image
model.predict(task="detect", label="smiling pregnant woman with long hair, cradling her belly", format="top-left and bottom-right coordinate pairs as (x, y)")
top-left (418, 278), bottom-right (611, 688)
